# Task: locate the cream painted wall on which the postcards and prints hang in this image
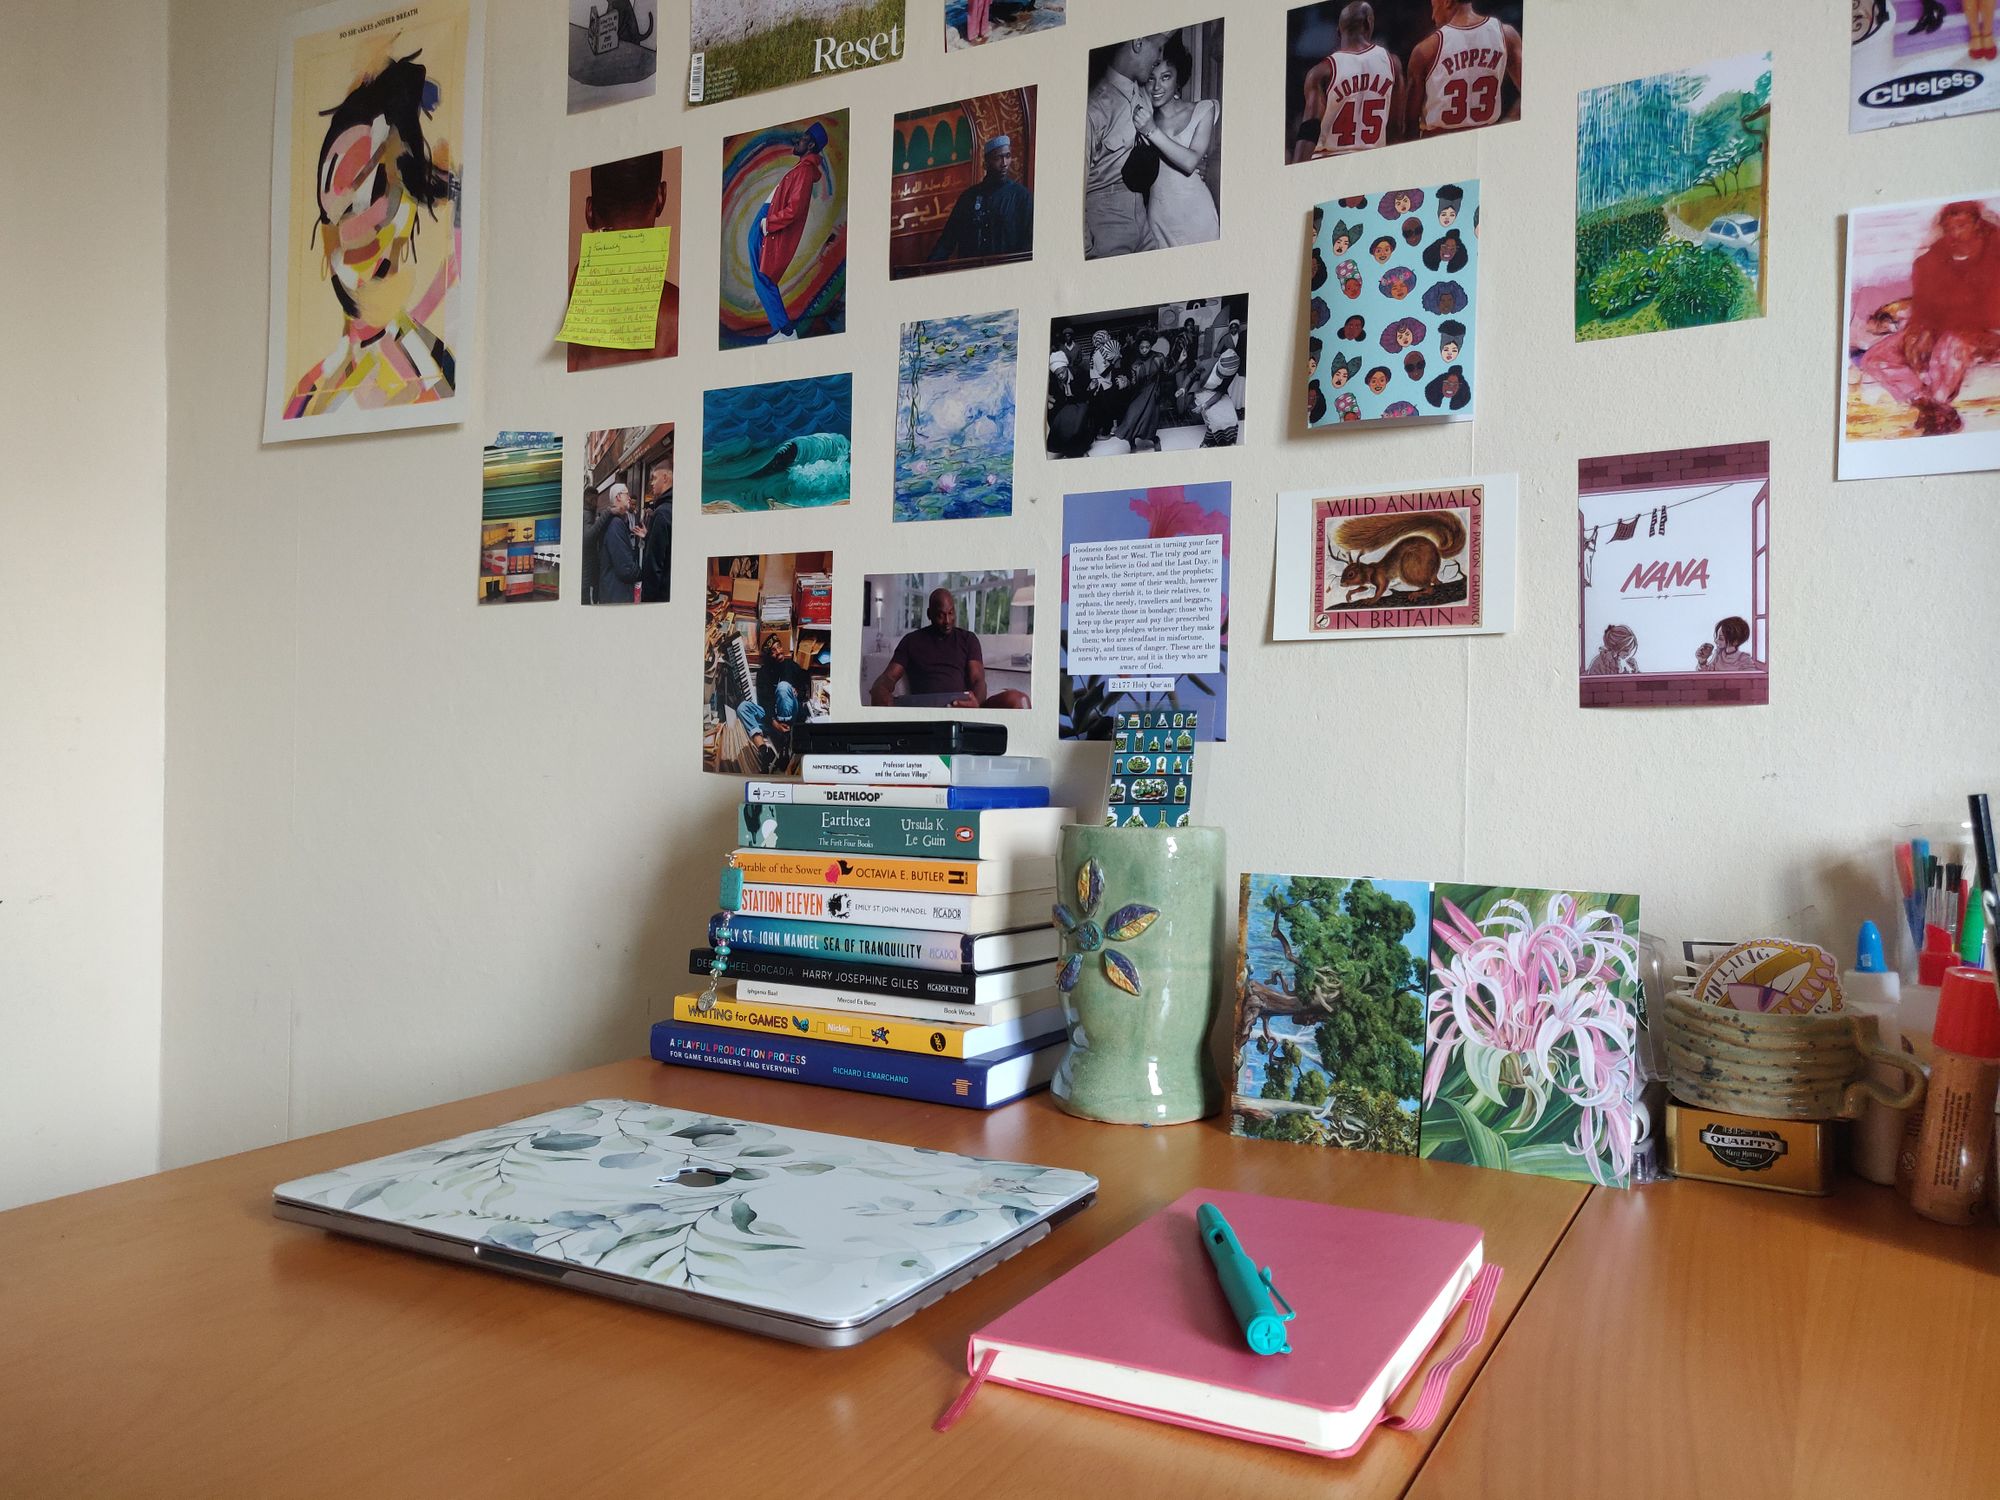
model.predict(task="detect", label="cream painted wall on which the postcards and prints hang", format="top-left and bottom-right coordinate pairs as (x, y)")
top-left (164, 0), bottom-right (2000, 1162)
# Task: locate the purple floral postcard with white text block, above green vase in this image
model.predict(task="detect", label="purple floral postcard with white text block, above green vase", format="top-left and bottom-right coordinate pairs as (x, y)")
top-left (1060, 482), bottom-right (1230, 740)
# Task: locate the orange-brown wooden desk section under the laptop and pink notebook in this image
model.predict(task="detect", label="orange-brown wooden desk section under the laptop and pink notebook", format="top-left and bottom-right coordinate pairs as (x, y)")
top-left (0, 1060), bottom-right (1584, 1500)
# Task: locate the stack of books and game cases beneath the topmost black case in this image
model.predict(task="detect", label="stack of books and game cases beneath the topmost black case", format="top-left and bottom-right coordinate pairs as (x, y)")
top-left (652, 754), bottom-right (1076, 1110)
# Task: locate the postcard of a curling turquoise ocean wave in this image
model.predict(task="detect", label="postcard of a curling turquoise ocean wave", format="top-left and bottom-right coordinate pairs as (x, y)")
top-left (702, 374), bottom-right (854, 516)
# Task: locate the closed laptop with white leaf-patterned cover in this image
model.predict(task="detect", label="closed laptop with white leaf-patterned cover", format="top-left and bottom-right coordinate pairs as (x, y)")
top-left (272, 1098), bottom-right (1098, 1348)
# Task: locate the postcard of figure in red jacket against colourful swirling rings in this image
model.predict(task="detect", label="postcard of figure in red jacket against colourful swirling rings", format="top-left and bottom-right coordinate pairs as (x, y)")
top-left (722, 110), bottom-right (848, 348)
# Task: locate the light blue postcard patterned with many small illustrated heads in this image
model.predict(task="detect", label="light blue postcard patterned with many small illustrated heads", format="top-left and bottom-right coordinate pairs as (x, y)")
top-left (1306, 182), bottom-right (1480, 428)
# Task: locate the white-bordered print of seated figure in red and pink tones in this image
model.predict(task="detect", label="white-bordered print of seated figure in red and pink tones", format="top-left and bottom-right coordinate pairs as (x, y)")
top-left (1840, 192), bottom-right (2000, 480)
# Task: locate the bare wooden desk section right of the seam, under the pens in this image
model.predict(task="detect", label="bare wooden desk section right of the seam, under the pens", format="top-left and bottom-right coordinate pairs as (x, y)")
top-left (1410, 1178), bottom-right (2000, 1500)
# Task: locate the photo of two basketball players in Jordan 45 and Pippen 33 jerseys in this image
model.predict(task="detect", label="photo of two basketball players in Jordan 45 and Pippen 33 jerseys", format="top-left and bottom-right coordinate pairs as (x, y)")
top-left (1284, 0), bottom-right (1526, 162)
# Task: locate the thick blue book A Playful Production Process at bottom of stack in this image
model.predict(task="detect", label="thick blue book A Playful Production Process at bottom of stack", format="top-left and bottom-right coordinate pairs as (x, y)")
top-left (652, 1020), bottom-right (1068, 1110)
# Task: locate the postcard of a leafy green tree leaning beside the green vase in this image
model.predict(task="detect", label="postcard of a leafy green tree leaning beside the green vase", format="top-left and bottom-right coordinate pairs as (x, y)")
top-left (1230, 874), bottom-right (1430, 1156)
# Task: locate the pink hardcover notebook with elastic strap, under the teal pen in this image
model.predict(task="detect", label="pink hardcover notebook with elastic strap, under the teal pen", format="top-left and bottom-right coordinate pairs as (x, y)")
top-left (940, 1188), bottom-right (1500, 1456)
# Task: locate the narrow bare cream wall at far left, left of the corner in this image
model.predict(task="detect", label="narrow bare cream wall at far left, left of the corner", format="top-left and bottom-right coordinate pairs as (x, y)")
top-left (0, 0), bottom-right (166, 1208)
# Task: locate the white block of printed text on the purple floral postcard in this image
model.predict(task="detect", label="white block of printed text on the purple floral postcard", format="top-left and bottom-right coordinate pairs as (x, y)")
top-left (1070, 536), bottom-right (1222, 676)
